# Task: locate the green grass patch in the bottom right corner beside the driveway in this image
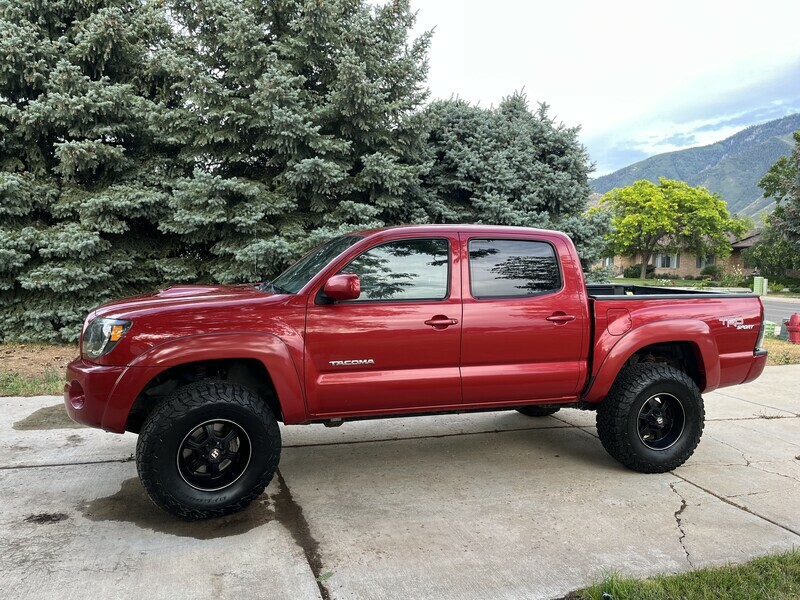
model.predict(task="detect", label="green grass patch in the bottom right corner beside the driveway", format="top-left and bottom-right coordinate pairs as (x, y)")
top-left (567, 550), bottom-right (800, 600)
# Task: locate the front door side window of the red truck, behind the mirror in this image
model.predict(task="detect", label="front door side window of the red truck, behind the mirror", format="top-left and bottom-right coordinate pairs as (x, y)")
top-left (341, 239), bottom-right (450, 302)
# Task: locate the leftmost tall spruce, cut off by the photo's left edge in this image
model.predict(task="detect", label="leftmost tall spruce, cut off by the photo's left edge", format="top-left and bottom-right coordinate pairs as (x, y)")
top-left (0, 0), bottom-right (188, 341)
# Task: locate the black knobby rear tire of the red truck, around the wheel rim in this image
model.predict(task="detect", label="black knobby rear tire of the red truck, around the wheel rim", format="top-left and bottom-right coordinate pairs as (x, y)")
top-left (597, 363), bottom-right (705, 473)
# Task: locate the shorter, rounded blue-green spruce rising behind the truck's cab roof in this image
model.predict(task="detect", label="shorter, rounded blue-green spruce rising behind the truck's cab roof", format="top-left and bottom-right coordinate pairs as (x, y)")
top-left (425, 93), bottom-right (606, 265)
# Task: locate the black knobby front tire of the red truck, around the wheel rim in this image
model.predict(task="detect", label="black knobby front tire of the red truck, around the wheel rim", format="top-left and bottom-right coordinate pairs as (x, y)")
top-left (136, 381), bottom-right (281, 521)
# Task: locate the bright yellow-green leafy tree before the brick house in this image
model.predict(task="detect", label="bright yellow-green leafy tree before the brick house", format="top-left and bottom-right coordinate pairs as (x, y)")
top-left (600, 178), bottom-right (749, 279)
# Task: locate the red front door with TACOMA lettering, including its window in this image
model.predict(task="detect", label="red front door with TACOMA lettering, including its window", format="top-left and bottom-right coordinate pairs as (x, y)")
top-left (305, 235), bottom-right (461, 418)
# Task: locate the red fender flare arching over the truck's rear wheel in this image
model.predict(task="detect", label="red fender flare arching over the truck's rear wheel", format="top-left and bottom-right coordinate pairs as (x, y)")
top-left (582, 319), bottom-right (720, 402)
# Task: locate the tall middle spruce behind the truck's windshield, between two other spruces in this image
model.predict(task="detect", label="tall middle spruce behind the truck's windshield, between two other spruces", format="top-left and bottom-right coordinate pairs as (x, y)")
top-left (162, 0), bottom-right (429, 282)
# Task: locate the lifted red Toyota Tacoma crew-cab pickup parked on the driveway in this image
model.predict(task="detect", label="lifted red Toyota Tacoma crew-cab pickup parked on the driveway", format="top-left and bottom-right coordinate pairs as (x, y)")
top-left (64, 225), bottom-right (767, 519)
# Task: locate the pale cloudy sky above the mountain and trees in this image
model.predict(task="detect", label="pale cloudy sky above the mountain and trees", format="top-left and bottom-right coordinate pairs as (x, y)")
top-left (412, 0), bottom-right (800, 176)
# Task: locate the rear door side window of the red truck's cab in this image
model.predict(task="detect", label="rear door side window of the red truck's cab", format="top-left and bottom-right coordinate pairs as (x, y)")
top-left (469, 240), bottom-right (561, 298)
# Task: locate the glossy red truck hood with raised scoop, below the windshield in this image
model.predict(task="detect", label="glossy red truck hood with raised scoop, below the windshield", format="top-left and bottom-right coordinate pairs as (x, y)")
top-left (90, 284), bottom-right (282, 319)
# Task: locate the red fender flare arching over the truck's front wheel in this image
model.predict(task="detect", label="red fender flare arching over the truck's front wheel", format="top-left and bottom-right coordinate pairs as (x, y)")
top-left (102, 332), bottom-right (307, 433)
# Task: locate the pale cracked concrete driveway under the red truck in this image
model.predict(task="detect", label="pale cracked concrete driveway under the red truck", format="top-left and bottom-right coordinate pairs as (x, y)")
top-left (0, 366), bottom-right (800, 600)
